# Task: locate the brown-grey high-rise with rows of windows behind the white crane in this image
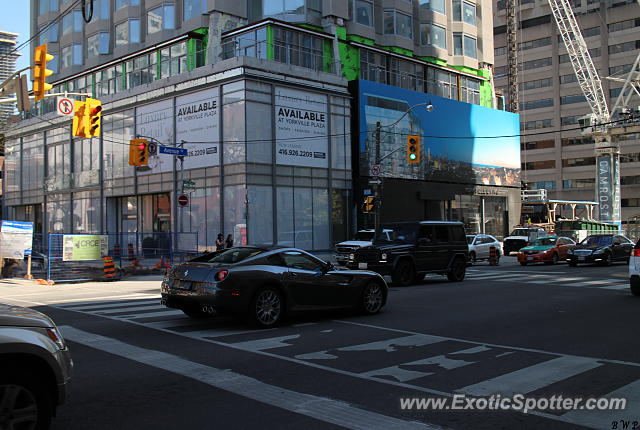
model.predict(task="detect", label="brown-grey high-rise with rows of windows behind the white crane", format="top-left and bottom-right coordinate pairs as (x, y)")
top-left (494, 0), bottom-right (640, 223)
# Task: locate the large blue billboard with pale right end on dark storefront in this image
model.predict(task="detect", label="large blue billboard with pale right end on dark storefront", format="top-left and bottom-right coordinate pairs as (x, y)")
top-left (358, 80), bottom-right (520, 188)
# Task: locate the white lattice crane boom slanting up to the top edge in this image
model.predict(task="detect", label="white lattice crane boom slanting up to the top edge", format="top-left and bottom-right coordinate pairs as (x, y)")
top-left (548, 0), bottom-right (611, 124)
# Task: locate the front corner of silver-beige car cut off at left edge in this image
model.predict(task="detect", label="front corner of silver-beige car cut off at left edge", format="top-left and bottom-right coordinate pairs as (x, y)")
top-left (0, 303), bottom-right (73, 429)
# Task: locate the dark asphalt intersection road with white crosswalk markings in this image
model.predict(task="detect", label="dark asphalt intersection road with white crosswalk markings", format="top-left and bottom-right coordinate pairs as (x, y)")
top-left (0, 257), bottom-right (640, 430)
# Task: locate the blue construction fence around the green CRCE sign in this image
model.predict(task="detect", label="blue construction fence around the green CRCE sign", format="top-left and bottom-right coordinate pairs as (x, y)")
top-left (40, 233), bottom-right (199, 283)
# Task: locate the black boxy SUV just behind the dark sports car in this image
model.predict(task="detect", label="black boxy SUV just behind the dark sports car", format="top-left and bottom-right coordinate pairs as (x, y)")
top-left (347, 221), bottom-right (469, 286)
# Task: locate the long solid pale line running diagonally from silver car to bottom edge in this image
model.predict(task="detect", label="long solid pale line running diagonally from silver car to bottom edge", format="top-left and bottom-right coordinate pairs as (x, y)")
top-left (61, 326), bottom-right (441, 430)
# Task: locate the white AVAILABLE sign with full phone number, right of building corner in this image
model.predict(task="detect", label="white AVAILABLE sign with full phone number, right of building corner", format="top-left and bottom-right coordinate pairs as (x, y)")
top-left (275, 87), bottom-right (329, 168)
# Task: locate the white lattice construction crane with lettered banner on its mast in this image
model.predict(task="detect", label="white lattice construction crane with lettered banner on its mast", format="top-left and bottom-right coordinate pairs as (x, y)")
top-left (506, 0), bottom-right (640, 224)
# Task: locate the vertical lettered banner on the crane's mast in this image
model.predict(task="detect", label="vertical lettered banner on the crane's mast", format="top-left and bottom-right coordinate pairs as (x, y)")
top-left (596, 155), bottom-right (620, 223)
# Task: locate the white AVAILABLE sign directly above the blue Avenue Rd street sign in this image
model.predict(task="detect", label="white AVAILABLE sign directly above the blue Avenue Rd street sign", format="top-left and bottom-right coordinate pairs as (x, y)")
top-left (176, 88), bottom-right (220, 169)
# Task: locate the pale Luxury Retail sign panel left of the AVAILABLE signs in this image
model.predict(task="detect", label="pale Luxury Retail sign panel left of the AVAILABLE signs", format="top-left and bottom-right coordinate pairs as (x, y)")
top-left (136, 99), bottom-right (175, 174)
